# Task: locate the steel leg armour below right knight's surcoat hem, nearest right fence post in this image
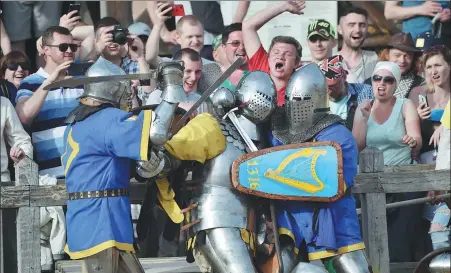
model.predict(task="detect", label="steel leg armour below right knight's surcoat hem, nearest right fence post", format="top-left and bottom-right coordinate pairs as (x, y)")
top-left (325, 250), bottom-right (373, 273)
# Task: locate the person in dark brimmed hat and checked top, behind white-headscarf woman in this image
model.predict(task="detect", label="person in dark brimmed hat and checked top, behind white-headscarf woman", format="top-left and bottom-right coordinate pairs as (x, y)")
top-left (365, 32), bottom-right (426, 99)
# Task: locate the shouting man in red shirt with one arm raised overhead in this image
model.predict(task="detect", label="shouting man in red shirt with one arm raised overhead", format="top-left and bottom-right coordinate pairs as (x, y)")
top-left (243, 1), bottom-right (305, 106)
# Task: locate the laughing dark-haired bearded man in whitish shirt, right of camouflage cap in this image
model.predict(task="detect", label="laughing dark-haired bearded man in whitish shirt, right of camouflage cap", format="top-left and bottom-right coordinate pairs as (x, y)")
top-left (338, 7), bottom-right (378, 83)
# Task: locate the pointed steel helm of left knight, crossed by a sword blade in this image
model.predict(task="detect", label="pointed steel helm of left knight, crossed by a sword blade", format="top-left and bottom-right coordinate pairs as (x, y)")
top-left (81, 57), bottom-right (132, 108)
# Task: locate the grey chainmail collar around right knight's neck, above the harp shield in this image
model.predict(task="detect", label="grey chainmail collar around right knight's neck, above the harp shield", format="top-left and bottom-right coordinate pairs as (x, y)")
top-left (271, 107), bottom-right (345, 144)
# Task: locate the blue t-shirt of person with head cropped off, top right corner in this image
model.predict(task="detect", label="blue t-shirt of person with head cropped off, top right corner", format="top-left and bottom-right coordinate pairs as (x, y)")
top-left (402, 1), bottom-right (450, 39)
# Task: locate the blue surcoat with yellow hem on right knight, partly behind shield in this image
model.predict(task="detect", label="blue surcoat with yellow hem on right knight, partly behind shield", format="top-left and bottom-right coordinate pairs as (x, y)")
top-left (271, 124), bottom-right (365, 260)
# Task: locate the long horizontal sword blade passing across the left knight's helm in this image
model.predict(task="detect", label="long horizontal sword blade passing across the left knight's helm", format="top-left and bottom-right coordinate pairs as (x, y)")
top-left (44, 71), bottom-right (156, 90)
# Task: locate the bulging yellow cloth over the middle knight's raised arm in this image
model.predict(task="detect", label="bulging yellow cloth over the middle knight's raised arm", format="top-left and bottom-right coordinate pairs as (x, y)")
top-left (164, 113), bottom-right (226, 163)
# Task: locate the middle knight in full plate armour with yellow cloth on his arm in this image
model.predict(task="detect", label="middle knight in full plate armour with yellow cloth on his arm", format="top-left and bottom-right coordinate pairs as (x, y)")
top-left (140, 71), bottom-right (276, 273)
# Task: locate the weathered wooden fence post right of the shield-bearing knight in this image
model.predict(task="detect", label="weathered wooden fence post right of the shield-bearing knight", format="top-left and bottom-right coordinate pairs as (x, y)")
top-left (359, 147), bottom-right (390, 273)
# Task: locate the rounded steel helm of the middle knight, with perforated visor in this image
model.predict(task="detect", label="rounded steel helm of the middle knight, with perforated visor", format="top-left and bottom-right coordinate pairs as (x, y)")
top-left (236, 71), bottom-right (277, 123)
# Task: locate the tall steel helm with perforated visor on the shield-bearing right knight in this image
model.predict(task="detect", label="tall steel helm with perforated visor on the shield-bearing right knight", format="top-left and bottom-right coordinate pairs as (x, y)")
top-left (285, 63), bottom-right (329, 134)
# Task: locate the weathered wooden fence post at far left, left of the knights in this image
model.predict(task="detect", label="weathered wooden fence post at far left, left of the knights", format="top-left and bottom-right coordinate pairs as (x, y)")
top-left (16, 157), bottom-right (41, 273)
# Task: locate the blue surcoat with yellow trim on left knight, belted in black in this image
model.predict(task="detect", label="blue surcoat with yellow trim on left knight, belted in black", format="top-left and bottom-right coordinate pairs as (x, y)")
top-left (61, 108), bottom-right (152, 259)
